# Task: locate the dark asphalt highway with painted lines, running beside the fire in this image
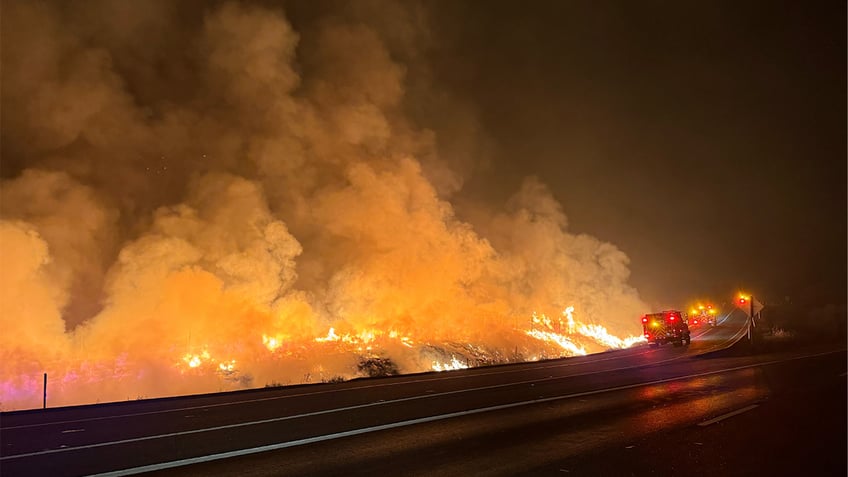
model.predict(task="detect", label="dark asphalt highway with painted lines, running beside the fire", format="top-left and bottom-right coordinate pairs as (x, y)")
top-left (0, 312), bottom-right (845, 477)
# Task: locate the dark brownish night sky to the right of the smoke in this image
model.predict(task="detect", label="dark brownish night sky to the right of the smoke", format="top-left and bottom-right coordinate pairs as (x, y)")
top-left (433, 2), bottom-right (846, 306)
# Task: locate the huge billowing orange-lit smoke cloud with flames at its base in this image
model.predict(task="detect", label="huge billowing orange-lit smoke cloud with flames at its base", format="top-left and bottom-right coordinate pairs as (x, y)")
top-left (0, 0), bottom-right (645, 410)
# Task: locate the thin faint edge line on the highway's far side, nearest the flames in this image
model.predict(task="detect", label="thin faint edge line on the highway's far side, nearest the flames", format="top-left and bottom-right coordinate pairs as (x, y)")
top-left (0, 348), bottom-right (665, 430)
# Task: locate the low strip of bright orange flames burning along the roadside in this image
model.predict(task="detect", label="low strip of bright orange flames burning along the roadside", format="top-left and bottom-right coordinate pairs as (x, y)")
top-left (2, 307), bottom-right (644, 410)
